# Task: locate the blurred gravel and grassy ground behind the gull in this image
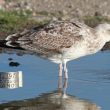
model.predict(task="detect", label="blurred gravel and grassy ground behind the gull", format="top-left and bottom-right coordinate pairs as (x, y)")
top-left (0, 0), bottom-right (110, 49)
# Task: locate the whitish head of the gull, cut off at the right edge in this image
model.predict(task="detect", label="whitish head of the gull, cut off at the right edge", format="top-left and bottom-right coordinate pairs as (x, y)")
top-left (96, 23), bottom-right (110, 42)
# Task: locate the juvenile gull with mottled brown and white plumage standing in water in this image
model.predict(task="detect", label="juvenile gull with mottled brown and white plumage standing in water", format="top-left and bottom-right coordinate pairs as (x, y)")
top-left (2, 20), bottom-right (110, 78)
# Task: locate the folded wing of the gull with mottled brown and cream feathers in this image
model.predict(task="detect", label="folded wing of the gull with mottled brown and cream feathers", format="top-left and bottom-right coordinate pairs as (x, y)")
top-left (6, 21), bottom-right (86, 54)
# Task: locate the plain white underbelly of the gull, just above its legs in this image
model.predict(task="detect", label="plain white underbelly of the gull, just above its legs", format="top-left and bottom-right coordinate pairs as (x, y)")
top-left (48, 42), bottom-right (100, 63)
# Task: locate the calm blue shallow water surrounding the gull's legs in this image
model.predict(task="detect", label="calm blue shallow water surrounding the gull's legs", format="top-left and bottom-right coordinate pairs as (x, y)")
top-left (0, 52), bottom-right (110, 110)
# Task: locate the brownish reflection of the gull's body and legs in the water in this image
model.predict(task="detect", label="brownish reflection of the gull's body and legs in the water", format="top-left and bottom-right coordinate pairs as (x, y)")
top-left (0, 77), bottom-right (100, 110)
